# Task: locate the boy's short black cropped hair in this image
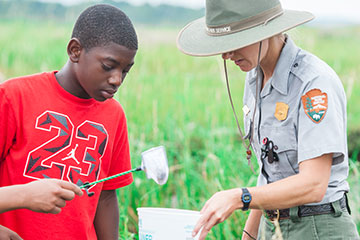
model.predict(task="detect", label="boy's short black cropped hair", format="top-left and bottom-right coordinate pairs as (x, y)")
top-left (71, 4), bottom-right (138, 50)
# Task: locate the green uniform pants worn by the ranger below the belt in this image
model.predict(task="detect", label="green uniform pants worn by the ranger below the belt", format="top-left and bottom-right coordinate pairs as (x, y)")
top-left (257, 201), bottom-right (360, 240)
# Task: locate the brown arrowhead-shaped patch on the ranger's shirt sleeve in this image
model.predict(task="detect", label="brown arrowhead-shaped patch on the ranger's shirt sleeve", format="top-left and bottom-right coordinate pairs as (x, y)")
top-left (301, 89), bottom-right (328, 123)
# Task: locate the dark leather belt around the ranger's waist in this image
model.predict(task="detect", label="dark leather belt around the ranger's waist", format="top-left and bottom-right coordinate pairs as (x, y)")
top-left (265, 195), bottom-right (347, 221)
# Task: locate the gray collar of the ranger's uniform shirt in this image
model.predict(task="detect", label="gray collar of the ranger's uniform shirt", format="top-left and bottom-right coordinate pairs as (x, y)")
top-left (247, 35), bottom-right (300, 96)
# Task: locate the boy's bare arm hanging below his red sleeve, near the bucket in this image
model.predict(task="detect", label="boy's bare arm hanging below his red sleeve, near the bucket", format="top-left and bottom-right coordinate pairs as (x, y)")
top-left (94, 190), bottom-right (119, 240)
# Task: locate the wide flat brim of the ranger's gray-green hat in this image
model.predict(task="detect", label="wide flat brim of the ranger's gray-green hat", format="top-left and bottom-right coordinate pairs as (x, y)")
top-left (176, 10), bottom-right (314, 57)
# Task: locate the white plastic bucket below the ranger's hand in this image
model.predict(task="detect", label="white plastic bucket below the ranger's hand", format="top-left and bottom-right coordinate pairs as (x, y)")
top-left (137, 208), bottom-right (200, 240)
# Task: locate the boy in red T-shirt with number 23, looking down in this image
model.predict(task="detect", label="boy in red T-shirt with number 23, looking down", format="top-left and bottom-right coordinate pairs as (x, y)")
top-left (0, 4), bottom-right (138, 240)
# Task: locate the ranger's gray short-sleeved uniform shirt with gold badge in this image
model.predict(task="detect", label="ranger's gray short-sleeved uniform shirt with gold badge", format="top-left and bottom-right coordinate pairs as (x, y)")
top-left (243, 37), bottom-right (349, 205)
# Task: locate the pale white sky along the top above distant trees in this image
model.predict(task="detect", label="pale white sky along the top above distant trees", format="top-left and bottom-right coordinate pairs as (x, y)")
top-left (42, 0), bottom-right (360, 24)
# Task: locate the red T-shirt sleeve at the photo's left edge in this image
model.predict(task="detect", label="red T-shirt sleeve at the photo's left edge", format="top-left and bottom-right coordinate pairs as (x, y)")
top-left (0, 85), bottom-right (16, 162)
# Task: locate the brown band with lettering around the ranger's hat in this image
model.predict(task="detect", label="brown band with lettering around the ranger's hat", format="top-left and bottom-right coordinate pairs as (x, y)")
top-left (206, 4), bottom-right (284, 36)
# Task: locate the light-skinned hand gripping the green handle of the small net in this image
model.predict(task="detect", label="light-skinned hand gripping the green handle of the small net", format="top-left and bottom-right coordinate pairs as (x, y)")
top-left (23, 179), bottom-right (83, 214)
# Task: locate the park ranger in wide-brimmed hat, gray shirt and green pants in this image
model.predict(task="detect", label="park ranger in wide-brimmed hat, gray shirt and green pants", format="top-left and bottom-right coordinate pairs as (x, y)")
top-left (177, 0), bottom-right (359, 240)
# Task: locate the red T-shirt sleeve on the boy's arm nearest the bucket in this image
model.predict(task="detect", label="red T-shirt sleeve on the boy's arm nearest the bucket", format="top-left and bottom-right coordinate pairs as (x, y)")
top-left (103, 110), bottom-right (133, 190)
